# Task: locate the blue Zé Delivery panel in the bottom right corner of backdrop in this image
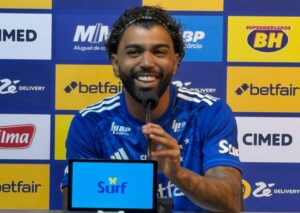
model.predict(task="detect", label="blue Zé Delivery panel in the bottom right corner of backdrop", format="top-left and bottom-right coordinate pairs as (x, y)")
top-left (243, 163), bottom-right (300, 212)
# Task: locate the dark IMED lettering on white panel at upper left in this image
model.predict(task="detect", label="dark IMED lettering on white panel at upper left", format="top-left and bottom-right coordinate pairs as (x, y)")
top-left (0, 29), bottom-right (37, 42)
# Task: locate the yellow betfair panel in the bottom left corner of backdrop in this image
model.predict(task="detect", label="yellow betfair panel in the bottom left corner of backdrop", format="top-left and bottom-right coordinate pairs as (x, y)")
top-left (0, 164), bottom-right (50, 209)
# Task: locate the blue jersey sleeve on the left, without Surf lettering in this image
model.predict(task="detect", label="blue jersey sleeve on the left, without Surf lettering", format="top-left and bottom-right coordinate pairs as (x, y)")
top-left (61, 113), bottom-right (97, 188)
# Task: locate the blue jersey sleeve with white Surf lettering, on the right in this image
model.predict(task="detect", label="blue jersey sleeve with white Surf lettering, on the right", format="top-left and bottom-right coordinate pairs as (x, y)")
top-left (203, 100), bottom-right (241, 171)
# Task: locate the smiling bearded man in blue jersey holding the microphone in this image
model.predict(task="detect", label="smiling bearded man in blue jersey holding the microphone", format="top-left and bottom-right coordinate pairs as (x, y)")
top-left (62, 6), bottom-right (241, 212)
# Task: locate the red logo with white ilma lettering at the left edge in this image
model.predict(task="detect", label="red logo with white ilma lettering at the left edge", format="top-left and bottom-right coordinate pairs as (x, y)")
top-left (0, 124), bottom-right (36, 149)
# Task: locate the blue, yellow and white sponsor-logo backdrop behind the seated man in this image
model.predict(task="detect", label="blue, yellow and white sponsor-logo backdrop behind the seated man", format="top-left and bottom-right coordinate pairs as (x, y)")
top-left (0, 0), bottom-right (300, 212)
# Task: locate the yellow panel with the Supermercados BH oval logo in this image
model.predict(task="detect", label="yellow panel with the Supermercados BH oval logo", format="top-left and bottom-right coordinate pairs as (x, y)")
top-left (228, 16), bottom-right (300, 62)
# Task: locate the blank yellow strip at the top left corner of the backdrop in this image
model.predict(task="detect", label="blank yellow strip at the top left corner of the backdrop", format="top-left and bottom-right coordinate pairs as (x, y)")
top-left (0, 0), bottom-right (52, 9)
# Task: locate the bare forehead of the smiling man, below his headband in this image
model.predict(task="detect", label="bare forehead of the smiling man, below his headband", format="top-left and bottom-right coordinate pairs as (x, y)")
top-left (119, 25), bottom-right (173, 48)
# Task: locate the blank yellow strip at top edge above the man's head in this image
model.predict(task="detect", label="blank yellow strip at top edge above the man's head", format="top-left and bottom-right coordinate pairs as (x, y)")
top-left (143, 0), bottom-right (224, 11)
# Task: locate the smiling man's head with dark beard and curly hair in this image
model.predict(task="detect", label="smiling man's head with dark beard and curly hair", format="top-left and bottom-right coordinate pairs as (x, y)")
top-left (106, 6), bottom-right (184, 104)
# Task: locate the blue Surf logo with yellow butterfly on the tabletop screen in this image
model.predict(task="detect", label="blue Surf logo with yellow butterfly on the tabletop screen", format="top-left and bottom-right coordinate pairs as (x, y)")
top-left (97, 177), bottom-right (128, 194)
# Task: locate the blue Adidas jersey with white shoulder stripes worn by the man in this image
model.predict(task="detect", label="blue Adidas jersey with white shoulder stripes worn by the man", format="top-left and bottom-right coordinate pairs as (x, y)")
top-left (62, 85), bottom-right (240, 211)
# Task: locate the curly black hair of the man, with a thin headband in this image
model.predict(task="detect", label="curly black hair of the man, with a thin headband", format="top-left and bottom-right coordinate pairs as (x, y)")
top-left (105, 6), bottom-right (185, 61)
